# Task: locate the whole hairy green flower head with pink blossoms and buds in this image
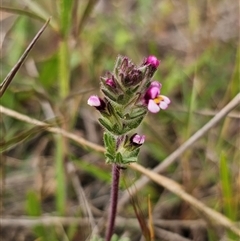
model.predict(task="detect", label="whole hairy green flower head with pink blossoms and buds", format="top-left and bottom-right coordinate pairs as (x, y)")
top-left (88, 56), bottom-right (170, 164)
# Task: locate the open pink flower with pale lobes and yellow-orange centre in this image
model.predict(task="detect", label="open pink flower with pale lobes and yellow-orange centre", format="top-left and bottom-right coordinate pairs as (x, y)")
top-left (144, 81), bottom-right (171, 113)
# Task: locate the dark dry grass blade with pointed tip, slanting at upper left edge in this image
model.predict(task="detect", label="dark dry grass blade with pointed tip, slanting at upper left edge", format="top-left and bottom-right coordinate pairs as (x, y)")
top-left (0, 18), bottom-right (50, 98)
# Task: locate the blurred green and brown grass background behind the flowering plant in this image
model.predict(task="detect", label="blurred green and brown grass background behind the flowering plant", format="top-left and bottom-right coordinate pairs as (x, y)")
top-left (0, 0), bottom-right (240, 241)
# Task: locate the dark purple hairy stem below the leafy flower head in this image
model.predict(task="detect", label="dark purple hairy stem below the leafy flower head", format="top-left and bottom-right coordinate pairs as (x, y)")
top-left (106, 164), bottom-right (120, 241)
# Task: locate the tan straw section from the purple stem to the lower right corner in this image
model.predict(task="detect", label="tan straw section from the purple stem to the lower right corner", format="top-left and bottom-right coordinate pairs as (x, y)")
top-left (131, 163), bottom-right (240, 237)
